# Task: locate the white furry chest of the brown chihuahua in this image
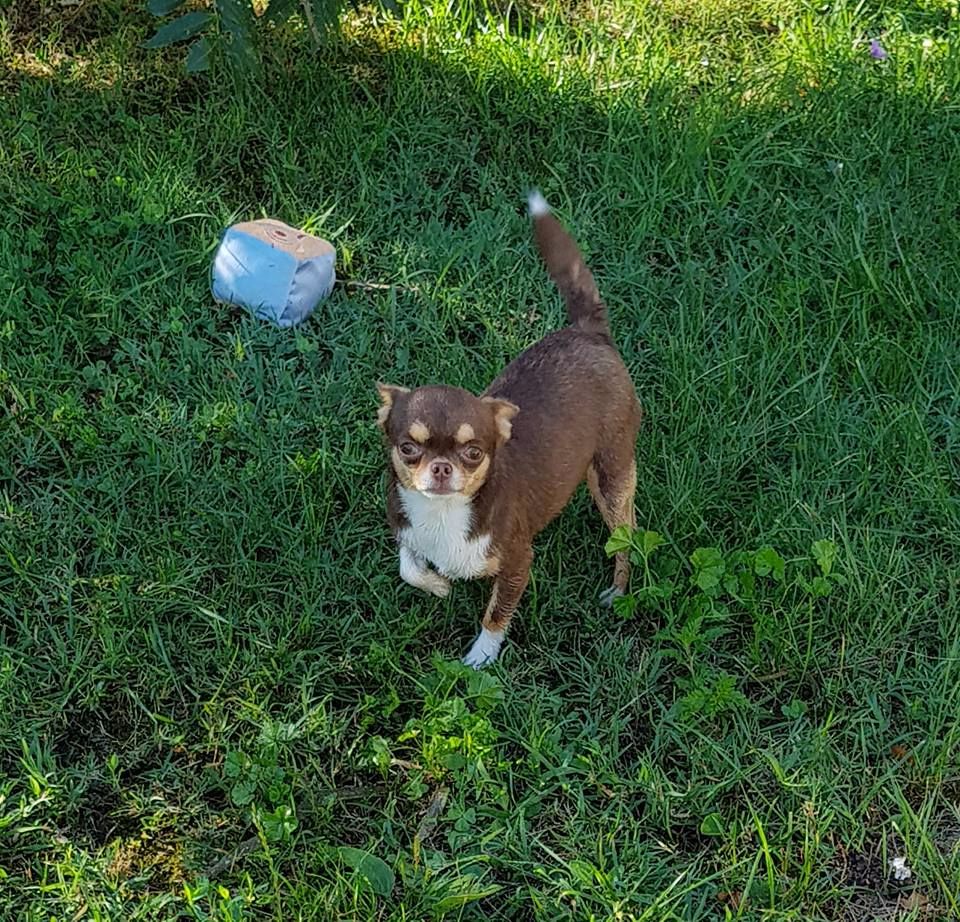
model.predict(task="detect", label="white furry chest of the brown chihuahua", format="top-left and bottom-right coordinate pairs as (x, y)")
top-left (398, 487), bottom-right (490, 579)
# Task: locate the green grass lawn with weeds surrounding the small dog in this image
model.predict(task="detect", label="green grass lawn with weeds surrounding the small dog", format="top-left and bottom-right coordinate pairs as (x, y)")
top-left (0, 0), bottom-right (960, 922)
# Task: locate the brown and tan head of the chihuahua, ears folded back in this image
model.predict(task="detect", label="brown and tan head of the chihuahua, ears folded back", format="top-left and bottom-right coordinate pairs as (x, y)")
top-left (377, 384), bottom-right (518, 497)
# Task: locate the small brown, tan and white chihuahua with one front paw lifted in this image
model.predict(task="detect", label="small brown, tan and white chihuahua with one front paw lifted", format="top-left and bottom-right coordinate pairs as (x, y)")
top-left (377, 192), bottom-right (642, 668)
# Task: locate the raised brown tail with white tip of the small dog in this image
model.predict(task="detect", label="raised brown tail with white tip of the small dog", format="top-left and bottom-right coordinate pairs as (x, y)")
top-left (527, 190), bottom-right (610, 336)
